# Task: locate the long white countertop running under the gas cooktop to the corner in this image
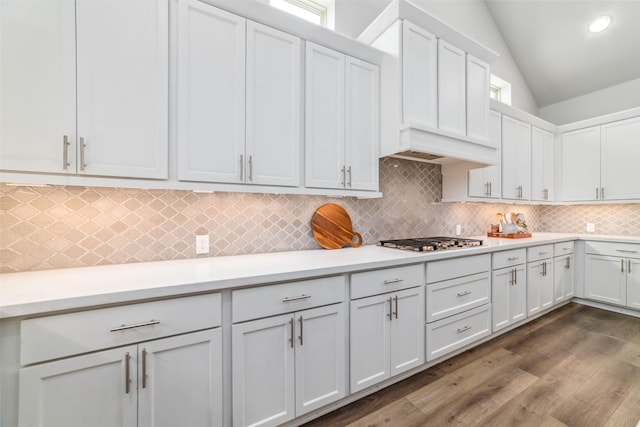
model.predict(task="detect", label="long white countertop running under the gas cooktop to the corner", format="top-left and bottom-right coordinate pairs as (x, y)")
top-left (0, 233), bottom-right (640, 319)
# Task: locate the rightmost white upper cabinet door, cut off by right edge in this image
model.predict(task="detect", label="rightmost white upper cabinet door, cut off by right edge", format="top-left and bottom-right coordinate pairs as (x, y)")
top-left (600, 117), bottom-right (640, 200)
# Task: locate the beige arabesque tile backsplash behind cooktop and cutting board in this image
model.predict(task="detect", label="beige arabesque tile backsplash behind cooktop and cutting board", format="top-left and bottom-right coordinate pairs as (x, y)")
top-left (0, 158), bottom-right (640, 273)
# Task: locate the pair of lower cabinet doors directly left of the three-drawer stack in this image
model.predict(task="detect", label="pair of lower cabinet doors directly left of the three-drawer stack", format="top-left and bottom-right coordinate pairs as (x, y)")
top-left (350, 286), bottom-right (425, 393)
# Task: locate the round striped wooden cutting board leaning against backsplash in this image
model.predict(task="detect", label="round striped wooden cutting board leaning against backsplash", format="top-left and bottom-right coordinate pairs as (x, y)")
top-left (311, 203), bottom-right (362, 249)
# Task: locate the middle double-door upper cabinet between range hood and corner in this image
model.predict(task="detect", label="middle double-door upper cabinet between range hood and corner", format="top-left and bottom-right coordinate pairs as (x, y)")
top-left (502, 115), bottom-right (531, 200)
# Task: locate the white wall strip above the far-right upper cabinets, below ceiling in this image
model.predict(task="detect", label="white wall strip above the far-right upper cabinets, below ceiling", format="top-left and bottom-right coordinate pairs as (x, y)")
top-left (537, 78), bottom-right (640, 125)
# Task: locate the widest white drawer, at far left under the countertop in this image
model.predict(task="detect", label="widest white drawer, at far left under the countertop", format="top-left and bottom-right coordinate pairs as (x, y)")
top-left (20, 294), bottom-right (221, 365)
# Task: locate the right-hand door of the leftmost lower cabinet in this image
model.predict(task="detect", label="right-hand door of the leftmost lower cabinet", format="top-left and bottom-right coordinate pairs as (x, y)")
top-left (134, 328), bottom-right (222, 427)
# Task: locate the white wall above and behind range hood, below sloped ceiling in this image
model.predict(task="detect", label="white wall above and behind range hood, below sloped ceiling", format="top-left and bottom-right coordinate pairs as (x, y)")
top-left (336, 0), bottom-right (538, 115)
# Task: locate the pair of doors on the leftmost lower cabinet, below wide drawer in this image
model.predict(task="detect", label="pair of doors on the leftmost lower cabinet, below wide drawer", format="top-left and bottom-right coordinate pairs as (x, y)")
top-left (19, 328), bottom-right (222, 427)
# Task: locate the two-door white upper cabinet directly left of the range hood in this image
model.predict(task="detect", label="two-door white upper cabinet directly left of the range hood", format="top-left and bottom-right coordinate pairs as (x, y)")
top-left (305, 42), bottom-right (379, 190)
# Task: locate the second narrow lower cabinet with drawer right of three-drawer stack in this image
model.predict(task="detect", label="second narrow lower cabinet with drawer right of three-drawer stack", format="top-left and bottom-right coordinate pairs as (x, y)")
top-left (527, 245), bottom-right (554, 315)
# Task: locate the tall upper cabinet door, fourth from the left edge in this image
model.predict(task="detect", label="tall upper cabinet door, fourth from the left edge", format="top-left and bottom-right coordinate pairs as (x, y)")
top-left (245, 21), bottom-right (302, 187)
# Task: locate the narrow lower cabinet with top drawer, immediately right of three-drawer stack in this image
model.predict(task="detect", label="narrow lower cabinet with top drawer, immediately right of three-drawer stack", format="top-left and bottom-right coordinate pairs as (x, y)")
top-left (491, 249), bottom-right (527, 332)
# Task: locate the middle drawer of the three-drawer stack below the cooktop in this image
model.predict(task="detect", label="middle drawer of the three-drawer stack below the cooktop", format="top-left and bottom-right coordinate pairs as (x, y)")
top-left (427, 271), bottom-right (491, 323)
